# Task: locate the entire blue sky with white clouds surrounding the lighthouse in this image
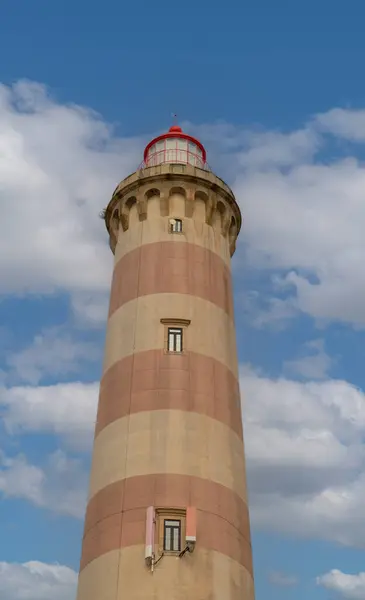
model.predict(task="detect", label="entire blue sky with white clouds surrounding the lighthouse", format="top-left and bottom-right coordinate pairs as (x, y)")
top-left (0, 0), bottom-right (365, 600)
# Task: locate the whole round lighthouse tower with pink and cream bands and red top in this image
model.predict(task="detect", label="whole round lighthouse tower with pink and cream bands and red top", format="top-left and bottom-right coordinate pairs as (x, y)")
top-left (77, 126), bottom-right (254, 600)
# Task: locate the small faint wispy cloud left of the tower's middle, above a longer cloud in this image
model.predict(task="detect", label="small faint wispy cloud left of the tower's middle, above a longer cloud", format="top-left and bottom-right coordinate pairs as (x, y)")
top-left (6, 327), bottom-right (100, 385)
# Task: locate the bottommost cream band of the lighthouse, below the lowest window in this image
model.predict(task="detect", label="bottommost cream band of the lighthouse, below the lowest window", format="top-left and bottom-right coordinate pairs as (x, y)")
top-left (77, 545), bottom-right (254, 600)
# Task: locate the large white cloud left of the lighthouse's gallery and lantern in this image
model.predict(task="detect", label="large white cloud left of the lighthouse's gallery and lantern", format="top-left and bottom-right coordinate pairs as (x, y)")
top-left (0, 82), bottom-right (141, 324)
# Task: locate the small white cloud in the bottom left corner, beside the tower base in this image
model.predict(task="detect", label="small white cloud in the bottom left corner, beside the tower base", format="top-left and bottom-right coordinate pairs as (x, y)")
top-left (0, 561), bottom-right (77, 600)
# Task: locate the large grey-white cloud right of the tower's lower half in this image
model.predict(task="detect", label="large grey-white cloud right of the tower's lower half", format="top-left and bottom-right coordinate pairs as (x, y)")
top-left (241, 369), bottom-right (365, 546)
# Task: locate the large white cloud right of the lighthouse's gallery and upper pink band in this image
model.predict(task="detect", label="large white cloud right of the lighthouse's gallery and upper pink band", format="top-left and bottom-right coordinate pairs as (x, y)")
top-left (196, 109), bottom-right (365, 326)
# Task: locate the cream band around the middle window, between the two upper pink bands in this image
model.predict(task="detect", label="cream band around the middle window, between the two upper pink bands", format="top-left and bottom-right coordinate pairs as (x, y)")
top-left (104, 294), bottom-right (238, 377)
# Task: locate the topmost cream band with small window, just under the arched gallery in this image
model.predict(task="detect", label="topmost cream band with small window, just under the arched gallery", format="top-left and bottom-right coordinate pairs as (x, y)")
top-left (114, 215), bottom-right (231, 267)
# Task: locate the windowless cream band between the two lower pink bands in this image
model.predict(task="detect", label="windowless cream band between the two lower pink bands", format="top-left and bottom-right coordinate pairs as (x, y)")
top-left (89, 410), bottom-right (247, 501)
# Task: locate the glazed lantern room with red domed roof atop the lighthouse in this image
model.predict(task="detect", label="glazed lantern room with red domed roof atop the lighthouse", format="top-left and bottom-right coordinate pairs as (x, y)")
top-left (144, 125), bottom-right (206, 169)
